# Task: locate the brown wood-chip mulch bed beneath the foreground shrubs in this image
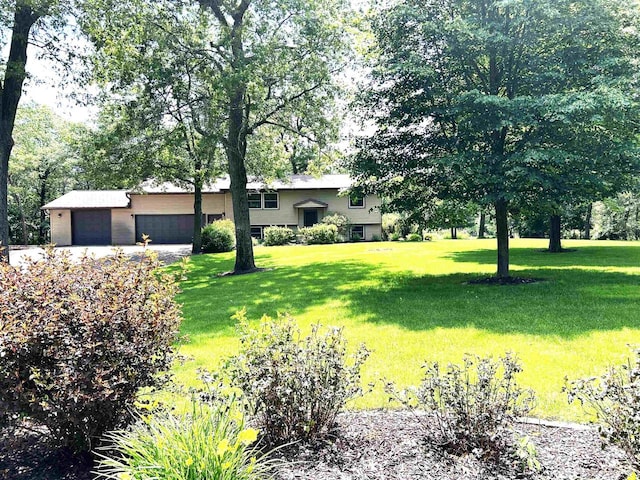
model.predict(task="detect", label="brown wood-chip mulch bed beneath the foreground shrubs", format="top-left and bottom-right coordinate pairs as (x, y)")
top-left (0, 411), bottom-right (631, 480)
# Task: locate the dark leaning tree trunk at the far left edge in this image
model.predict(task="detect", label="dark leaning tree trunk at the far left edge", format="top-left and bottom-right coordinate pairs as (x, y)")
top-left (0, 2), bottom-right (39, 262)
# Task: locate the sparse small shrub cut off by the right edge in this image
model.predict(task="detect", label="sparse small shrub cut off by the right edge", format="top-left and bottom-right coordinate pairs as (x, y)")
top-left (564, 350), bottom-right (640, 472)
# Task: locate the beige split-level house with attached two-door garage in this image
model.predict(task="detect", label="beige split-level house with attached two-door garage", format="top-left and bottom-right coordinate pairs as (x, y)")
top-left (42, 175), bottom-right (382, 246)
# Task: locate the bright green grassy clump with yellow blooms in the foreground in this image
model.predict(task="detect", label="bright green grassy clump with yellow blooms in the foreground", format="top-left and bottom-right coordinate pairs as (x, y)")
top-left (97, 401), bottom-right (271, 480)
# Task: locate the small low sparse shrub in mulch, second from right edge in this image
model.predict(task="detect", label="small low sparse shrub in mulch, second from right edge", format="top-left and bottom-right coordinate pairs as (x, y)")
top-left (387, 354), bottom-right (534, 460)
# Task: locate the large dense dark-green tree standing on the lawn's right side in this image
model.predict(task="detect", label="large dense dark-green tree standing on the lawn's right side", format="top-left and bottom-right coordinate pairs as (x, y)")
top-left (351, 0), bottom-right (638, 279)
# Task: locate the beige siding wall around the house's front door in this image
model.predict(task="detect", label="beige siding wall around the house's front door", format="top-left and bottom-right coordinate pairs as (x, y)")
top-left (242, 190), bottom-right (382, 229)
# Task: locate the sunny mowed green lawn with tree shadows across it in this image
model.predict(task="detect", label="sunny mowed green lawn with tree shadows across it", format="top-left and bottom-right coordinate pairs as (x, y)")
top-left (170, 240), bottom-right (640, 420)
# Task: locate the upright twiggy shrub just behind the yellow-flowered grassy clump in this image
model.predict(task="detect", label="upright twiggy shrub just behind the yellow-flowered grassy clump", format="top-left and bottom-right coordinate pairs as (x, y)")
top-left (226, 311), bottom-right (369, 445)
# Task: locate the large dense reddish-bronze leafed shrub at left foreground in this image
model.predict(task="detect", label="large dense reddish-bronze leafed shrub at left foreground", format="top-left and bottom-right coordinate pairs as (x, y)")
top-left (0, 249), bottom-right (180, 450)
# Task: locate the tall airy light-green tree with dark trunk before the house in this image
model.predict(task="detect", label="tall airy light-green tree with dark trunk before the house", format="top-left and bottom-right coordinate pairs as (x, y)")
top-left (85, 0), bottom-right (348, 273)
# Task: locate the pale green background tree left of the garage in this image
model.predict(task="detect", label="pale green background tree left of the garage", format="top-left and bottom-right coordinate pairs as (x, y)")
top-left (8, 104), bottom-right (82, 245)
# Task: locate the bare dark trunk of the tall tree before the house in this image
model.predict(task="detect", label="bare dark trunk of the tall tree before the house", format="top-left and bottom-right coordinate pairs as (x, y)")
top-left (226, 86), bottom-right (256, 273)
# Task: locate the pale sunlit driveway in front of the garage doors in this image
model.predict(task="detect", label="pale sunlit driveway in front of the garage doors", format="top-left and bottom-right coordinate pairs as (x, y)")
top-left (9, 245), bottom-right (191, 265)
